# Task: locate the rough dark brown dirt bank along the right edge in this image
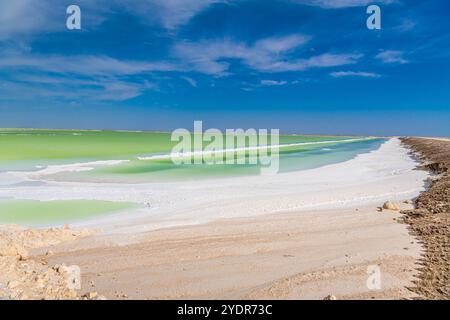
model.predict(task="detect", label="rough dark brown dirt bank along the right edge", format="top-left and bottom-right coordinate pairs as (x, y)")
top-left (402, 138), bottom-right (450, 299)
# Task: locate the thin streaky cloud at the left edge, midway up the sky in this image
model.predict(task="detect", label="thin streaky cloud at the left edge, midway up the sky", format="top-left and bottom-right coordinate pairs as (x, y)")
top-left (0, 53), bottom-right (167, 101)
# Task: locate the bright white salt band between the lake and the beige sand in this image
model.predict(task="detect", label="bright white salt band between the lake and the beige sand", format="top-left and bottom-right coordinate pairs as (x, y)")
top-left (2, 139), bottom-right (427, 234)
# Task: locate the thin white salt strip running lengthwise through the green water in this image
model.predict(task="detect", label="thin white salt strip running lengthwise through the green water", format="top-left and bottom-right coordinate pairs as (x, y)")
top-left (138, 138), bottom-right (372, 160)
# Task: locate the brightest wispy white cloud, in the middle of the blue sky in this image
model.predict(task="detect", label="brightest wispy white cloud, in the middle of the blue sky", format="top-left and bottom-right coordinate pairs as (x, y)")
top-left (172, 34), bottom-right (361, 76)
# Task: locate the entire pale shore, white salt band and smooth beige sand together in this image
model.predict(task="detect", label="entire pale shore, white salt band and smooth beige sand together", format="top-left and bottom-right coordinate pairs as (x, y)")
top-left (0, 139), bottom-right (428, 299)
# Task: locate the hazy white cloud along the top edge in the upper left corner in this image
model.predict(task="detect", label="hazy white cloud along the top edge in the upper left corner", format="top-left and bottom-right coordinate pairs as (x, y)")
top-left (0, 0), bottom-right (221, 41)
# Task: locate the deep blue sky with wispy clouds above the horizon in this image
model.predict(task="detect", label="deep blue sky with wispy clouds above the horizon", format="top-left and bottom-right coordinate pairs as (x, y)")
top-left (0, 0), bottom-right (450, 136)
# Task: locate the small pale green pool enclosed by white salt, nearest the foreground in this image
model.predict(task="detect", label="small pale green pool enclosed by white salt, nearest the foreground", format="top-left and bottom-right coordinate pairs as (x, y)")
top-left (0, 200), bottom-right (136, 225)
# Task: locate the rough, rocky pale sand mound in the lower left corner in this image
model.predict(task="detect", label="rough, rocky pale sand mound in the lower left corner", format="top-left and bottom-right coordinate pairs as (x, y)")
top-left (0, 226), bottom-right (100, 300)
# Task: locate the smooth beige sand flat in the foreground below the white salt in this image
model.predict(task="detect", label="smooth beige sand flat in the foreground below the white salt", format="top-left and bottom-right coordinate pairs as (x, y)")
top-left (38, 205), bottom-right (421, 299)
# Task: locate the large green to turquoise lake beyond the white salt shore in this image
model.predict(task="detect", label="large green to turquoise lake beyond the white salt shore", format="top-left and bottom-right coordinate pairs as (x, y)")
top-left (0, 129), bottom-right (383, 182)
